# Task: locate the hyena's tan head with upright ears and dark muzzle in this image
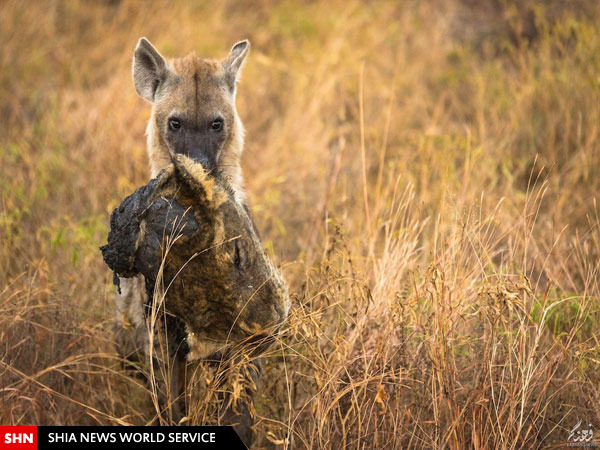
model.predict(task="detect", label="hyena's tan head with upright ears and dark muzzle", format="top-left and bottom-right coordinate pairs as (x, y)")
top-left (133, 38), bottom-right (250, 196)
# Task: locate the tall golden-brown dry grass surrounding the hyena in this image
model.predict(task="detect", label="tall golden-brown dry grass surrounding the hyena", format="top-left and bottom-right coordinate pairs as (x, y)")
top-left (0, 0), bottom-right (600, 449)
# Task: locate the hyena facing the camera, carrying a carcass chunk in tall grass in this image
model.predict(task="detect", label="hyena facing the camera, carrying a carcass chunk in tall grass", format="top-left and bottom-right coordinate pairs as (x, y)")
top-left (116, 38), bottom-right (282, 439)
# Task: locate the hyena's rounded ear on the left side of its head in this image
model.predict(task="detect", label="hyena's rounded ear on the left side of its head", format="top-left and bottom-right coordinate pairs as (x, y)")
top-left (133, 38), bottom-right (169, 103)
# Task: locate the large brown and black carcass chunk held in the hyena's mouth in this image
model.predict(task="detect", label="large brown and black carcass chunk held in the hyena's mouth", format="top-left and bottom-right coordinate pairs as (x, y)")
top-left (101, 155), bottom-right (289, 360)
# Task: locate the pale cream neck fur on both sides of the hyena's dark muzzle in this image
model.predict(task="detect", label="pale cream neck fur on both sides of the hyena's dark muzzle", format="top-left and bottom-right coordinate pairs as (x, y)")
top-left (146, 116), bottom-right (246, 203)
